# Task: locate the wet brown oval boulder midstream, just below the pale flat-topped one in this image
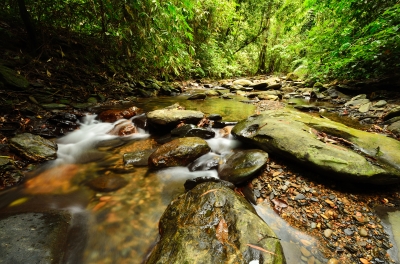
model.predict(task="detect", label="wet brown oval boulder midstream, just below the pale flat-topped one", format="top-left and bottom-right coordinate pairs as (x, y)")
top-left (149, 137), bottom-right (211, 168)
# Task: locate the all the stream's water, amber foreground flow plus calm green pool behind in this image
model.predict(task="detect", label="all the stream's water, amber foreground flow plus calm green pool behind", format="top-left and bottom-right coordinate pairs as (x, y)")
top-left (0, 96), bottom-right (400, 264)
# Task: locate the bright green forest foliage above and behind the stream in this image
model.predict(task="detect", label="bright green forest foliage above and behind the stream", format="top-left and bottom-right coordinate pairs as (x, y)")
top-left (0, 0), bottom-right (400, 80)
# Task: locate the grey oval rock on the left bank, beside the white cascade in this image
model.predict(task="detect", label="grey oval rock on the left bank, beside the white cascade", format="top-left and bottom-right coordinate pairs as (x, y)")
top-left (10, 133), bottom-right (57, 162)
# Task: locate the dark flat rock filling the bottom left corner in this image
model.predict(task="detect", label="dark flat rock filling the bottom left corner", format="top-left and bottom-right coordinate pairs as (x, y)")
top-left (0, 211), bottom-right (75, 263)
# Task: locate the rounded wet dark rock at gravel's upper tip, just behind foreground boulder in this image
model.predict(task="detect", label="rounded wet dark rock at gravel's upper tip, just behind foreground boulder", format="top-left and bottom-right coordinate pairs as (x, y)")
top-left (218, 149), bottom-right (268, 184)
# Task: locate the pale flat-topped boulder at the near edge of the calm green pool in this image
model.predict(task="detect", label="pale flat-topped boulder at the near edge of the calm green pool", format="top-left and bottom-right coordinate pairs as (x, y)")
top-left (147, 109), bottom-right (204, 130)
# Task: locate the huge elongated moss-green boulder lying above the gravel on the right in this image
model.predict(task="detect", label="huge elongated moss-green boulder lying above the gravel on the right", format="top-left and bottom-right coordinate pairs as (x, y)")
top-left (232, 110), bottom-right (400, 184)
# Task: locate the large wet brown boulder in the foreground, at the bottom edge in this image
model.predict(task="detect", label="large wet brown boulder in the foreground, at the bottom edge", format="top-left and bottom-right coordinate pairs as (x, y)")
top-left (146, 182), bottom-right (285, 264)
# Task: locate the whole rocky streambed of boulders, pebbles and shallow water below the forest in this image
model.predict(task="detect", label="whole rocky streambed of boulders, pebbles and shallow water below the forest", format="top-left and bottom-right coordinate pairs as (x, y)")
top-left (1, 70), bottom-right (400, 263)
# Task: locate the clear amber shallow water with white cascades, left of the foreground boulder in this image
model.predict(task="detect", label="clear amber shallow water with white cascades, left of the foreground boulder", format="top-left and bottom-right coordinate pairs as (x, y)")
top-left (0, 116), bottom-right (239, 263)
